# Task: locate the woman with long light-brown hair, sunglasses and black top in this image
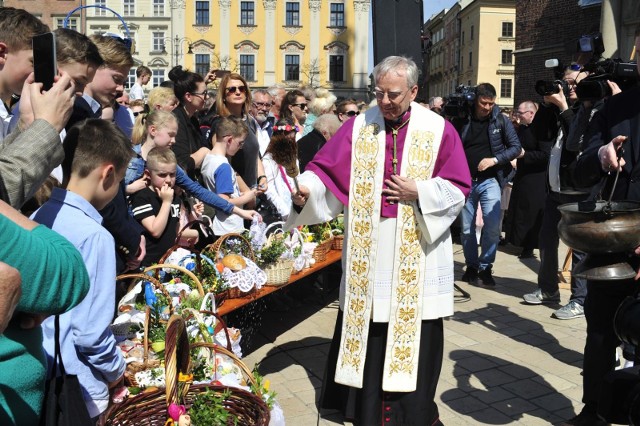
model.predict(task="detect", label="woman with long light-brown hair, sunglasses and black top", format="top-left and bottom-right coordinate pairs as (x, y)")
top-left (210, 72), bottom-right (267, 195)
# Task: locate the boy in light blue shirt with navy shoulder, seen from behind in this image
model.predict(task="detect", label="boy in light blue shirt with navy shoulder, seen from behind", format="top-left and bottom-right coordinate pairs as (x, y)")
top-left (33, 119), bottom-right (133, 420)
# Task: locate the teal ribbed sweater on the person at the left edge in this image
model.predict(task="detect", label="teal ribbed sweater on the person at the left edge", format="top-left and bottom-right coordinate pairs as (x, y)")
top-left (0, 215), bottom-right (89, 426)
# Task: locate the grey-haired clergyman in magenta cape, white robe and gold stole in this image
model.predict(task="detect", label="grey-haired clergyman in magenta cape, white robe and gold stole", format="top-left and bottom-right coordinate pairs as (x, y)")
top-left (287, 56), bottom-right (471, 425)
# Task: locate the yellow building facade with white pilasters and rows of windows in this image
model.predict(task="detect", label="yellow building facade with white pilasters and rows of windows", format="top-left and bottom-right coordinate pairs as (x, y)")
top-left (184, 0), bottom-right (371, 96)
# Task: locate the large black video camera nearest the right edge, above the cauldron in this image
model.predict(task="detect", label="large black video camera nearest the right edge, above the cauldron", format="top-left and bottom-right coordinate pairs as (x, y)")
top-left (576, 33), bottom-right (638, 101)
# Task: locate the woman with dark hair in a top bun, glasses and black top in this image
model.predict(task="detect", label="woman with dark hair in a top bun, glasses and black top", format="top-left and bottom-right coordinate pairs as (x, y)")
top-left (169, 65), bottom-right (209, 179)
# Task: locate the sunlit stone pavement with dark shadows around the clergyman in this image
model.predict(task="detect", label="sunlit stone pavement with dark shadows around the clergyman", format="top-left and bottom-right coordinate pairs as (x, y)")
top-left (244, 245), bottom-right (586, 426)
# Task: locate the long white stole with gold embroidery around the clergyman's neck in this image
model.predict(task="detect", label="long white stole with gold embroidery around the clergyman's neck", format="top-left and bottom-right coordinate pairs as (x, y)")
top-left (335, 107), bottom-right (442, 392)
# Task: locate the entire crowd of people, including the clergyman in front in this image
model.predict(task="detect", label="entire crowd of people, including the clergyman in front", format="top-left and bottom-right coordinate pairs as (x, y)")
top-left (0, 7), bottom-right (640, 425)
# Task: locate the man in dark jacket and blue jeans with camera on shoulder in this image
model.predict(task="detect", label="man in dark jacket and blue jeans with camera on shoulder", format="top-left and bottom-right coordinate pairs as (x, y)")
top-left (452, 83), bottom-right (524, 287)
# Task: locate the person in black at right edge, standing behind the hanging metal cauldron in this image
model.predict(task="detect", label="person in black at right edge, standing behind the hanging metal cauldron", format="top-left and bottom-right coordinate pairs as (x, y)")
top-left (569, 28), bottom-right (640, 425)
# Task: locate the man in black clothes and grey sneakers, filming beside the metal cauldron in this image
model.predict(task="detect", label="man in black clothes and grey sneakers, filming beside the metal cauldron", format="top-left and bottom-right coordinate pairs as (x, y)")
top-left (523, 64), bottom-right (589, 320)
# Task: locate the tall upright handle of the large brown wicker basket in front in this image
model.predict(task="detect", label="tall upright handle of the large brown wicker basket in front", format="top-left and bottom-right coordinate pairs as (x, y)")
top-left (164, 315), bottom-right (191, 407)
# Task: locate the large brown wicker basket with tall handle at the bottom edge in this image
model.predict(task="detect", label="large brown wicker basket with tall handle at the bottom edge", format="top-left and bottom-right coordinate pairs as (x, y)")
top-left (98, 316), bottom-right (270, 426)
